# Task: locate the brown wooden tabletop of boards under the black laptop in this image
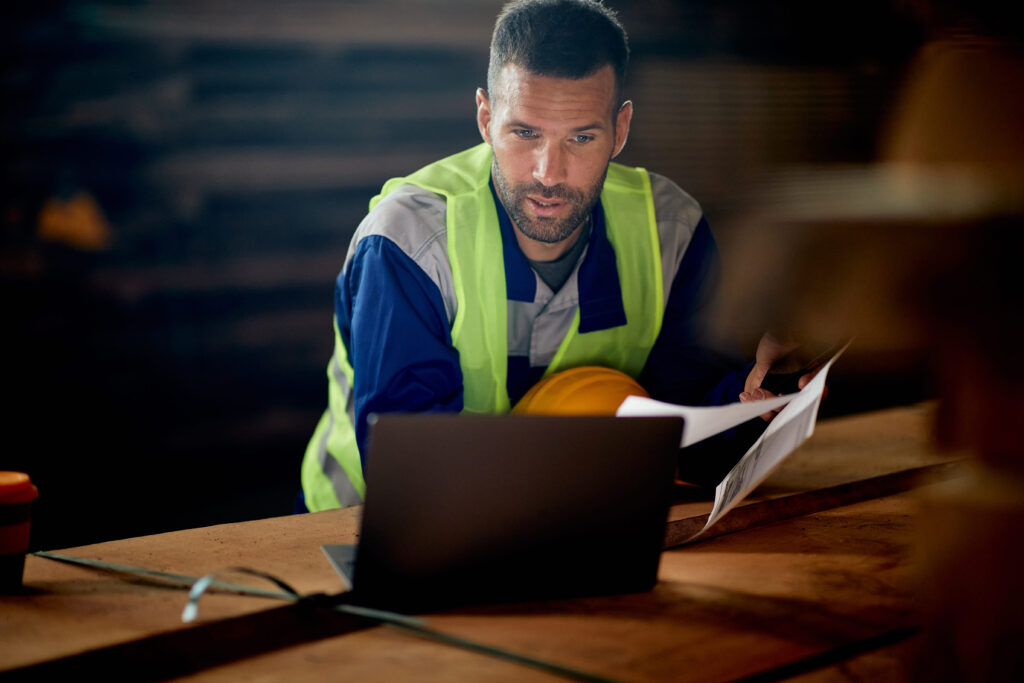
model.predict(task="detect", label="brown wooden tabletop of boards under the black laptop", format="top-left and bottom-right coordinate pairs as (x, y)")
top-left (0, 405), bottom-right (951, 683)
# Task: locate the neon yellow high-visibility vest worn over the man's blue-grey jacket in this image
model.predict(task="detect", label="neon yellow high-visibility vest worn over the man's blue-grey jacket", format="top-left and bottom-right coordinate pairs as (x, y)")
top-left (302, 143), bottom-right (665, 511)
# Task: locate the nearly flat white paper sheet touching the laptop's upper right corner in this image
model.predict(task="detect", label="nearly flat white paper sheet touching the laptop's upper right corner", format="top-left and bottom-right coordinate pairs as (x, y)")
top-left (615, 393), bottom-right (800, 446)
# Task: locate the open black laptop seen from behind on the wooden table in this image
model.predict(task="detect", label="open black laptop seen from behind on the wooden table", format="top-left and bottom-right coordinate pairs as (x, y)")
top-left (324, 414), bottom-right (683, 612)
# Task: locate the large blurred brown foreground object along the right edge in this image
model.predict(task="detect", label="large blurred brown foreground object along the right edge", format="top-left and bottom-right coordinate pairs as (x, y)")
top-left (720, 29), bottom-right (1024, 681)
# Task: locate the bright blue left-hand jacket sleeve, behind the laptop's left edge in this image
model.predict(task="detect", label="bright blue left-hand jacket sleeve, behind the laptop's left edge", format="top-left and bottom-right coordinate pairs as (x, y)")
top-left (335, 236), bottom-right (463, 467)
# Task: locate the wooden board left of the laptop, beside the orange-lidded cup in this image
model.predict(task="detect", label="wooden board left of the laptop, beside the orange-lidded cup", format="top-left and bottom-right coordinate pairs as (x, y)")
top-left (0, 509), bottom-right (358, 671)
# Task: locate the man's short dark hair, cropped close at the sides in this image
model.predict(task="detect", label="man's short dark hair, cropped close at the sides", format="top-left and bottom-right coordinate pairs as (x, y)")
top-left (487, 0), bottom-right (630, 109)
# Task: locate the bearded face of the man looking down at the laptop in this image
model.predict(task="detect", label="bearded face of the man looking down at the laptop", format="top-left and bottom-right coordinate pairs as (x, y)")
top-left (476, 65), bottom-right (633, 258)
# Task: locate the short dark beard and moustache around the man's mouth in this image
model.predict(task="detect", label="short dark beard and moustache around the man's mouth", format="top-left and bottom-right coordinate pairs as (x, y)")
top-left (492, 159), bottom-right (608, 244)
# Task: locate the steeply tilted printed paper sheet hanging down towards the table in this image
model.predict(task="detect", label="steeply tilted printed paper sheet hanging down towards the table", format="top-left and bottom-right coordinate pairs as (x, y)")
top-left (687, 344), bottom-right (849, 541)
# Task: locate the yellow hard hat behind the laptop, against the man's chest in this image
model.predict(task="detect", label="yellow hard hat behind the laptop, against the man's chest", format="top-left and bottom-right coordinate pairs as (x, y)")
top-left (512, 366), bottom-right (648, 415)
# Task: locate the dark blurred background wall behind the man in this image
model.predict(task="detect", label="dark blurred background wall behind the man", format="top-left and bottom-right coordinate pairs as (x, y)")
top-left (0, 0), bottom-right (928, 548)
